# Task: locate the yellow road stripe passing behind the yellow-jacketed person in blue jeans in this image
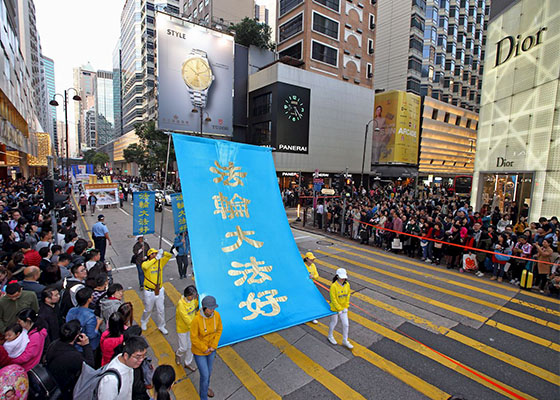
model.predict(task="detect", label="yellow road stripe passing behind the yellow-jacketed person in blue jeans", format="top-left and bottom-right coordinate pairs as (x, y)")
top-left (163, 282), bottom-right (281, 400)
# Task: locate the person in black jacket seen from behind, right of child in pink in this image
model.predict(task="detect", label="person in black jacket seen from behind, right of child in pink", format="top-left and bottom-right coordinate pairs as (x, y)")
top-left (47, 320), bottom-right (94, 400)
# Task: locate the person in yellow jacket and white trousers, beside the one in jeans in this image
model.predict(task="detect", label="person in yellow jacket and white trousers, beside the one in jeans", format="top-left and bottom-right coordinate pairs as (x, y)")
top-left (175, 285), bottom-right (198, 371)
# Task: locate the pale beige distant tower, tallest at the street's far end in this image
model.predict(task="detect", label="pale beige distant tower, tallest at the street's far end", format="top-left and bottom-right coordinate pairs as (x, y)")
top-left (73, 63), bottom-right (97, 156)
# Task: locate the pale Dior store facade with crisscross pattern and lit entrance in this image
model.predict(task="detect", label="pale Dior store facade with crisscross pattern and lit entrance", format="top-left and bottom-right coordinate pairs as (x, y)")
top-left (471, 0), bottom-right (560, 221)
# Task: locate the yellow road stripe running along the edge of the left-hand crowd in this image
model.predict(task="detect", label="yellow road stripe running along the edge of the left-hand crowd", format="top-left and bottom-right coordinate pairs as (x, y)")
top-left (124, 290), bottom-right (199, 399)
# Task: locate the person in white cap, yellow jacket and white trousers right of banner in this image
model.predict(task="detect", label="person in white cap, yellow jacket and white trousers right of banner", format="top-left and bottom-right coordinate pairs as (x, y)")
top-left (328, 268), bottom-right (354, 349)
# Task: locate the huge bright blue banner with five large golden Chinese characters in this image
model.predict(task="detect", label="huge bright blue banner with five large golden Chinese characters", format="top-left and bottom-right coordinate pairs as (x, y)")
top-left (173, 134), bottom-right (332, 346)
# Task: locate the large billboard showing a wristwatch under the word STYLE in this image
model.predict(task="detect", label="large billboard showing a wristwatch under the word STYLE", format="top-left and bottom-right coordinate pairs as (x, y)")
top-left (156, 13), bottom-right (234, 136)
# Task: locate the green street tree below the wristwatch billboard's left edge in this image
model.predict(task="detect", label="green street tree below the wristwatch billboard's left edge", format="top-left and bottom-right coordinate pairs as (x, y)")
top-left (123, 121), bottom-right (175, 177)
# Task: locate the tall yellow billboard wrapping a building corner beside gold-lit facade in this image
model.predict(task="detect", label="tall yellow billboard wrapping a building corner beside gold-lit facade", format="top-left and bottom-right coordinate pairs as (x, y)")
top-left (371, 90), bottom-right (420, 165)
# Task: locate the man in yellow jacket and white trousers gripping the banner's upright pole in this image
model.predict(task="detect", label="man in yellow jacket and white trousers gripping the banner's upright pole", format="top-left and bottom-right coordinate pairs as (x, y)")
top-left (140, 249), bottom-right (172, 335)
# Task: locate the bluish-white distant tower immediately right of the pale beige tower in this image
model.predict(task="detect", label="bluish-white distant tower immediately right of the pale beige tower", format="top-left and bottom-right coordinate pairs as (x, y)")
top-left (95, 71), bottom-right (115, 147)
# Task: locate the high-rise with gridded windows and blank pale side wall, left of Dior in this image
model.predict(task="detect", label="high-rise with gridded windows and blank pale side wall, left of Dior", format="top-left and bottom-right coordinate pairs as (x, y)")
top-left (374, 0), bottom-right (491, 112)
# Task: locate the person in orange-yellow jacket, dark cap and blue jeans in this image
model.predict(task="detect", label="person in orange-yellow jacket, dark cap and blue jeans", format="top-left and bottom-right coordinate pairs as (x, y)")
top-left (191, 296), bottom-right (222, 400)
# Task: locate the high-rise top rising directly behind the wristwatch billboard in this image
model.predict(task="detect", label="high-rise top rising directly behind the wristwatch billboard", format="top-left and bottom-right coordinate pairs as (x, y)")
top-left (179, 0), bottom-right (255, 29)
